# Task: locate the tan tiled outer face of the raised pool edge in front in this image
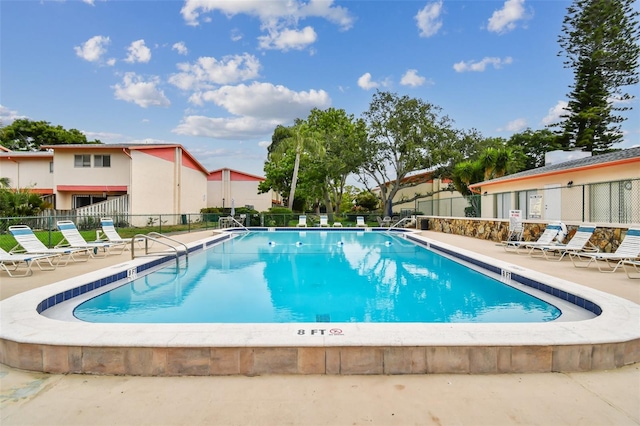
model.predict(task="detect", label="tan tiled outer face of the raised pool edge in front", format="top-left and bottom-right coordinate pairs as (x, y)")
top-left (0, 339), bottom-right (640, 376)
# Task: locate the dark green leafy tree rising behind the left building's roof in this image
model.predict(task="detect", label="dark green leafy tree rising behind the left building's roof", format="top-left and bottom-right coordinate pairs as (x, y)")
top-left (0, 119), bottom-right (101, 151)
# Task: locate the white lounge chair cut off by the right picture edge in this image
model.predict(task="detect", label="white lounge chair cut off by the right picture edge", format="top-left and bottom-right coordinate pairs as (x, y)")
top-left (569, 228), bottom-right (640, 272)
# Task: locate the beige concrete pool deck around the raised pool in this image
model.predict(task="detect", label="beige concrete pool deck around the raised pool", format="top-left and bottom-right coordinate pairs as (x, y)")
top-left (0, 231), bottom-right (640, 425)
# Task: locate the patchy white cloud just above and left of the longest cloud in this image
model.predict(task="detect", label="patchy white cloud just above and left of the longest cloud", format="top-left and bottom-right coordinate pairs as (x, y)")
top-left (169, 53), bottom-right (261, 90)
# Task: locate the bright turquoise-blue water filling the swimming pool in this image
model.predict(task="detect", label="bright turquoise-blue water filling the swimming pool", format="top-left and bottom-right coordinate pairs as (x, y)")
top-left (74, 231), bottom-right (561, 323)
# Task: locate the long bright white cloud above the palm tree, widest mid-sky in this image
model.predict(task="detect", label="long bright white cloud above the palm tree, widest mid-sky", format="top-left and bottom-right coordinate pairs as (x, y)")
top-left (191, 82), bottom-right (331, 122)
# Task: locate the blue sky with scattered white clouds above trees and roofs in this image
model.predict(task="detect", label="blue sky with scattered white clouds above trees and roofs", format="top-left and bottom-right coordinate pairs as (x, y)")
top-left (0, 0), bottom-right (640, 175)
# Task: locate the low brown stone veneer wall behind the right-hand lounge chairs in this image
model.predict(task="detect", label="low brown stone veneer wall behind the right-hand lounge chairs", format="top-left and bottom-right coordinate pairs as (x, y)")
top-left (417, 216), bottom-right (626, 253)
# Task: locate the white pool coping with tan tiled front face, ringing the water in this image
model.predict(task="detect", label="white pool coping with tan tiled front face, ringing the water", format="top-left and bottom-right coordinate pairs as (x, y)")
top-left (0, 228), bottom-right (640, 376)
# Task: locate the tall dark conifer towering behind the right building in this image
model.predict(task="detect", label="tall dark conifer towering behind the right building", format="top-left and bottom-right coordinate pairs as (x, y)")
top-left (559, 0), bottom-right (640, 153)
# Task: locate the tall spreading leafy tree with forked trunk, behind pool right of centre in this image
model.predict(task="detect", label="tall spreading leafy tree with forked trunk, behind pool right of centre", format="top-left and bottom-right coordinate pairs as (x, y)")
top-left (359, 91), bottom-right (455, 215)
